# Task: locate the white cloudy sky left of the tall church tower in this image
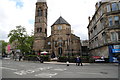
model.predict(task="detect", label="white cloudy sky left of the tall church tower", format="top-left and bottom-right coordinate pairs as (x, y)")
top-left (0, 0), bottom-right (36, 41)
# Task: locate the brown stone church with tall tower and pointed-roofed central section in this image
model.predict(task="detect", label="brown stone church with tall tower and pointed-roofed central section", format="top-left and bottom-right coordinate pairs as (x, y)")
top-left (33, 0), bottom-right (81, 57)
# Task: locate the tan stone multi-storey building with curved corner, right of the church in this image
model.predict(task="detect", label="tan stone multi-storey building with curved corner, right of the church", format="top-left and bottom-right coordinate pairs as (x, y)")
top-left (87, 0), bottom-right (120, 61)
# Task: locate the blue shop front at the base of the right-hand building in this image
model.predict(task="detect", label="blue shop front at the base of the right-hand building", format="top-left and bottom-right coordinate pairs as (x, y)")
top-left (109, 45), bottom-right (120, 62)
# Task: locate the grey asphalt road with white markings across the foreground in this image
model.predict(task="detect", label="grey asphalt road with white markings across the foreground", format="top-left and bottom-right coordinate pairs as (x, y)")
top-left (0, 59), bottom-right (118, 78)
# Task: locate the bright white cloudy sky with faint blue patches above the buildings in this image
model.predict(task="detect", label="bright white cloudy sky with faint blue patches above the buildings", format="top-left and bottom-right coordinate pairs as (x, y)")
top-left (0, 0), bottom-right (98, 42)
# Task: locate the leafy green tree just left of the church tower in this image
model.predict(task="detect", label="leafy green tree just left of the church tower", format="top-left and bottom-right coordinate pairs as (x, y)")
top-left (8, 26), bottom-right (33, 53)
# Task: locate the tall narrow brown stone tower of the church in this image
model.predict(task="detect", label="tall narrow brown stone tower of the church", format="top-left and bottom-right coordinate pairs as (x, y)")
top-left (33, 0), bottom-right (48, 52)
